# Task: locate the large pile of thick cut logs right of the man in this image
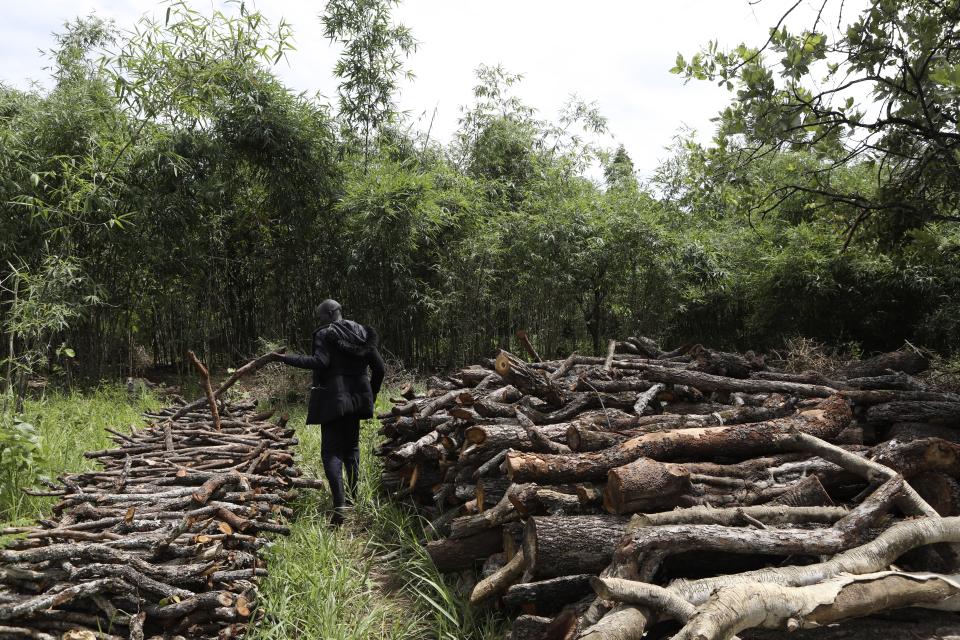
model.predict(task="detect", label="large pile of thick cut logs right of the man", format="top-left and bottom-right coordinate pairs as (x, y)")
top-left (378, 338), bottom-right (960, 640)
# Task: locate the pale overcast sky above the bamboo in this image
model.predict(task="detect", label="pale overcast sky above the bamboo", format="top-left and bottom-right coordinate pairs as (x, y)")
top-left (0, 0), bottom-right (865, 180)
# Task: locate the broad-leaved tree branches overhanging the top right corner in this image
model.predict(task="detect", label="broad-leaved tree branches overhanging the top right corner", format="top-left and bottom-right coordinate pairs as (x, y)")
top-left (671, 0), bottom-right (960, 244)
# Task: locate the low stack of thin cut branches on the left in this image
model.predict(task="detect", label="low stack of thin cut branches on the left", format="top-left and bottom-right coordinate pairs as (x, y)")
top-left (0, 352), bottom-right (319, 640)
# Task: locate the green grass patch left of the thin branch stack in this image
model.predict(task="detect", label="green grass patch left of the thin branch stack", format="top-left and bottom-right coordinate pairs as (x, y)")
top-left (0, 385), bottom-right (159, 524)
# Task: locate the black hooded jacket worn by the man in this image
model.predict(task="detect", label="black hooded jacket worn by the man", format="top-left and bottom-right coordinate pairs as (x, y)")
top-left (283, 320), bottom-right (384, 424)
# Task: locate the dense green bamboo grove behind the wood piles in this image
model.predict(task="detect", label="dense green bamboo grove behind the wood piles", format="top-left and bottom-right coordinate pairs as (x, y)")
top-left (0, 0), bottom-right (960, 396)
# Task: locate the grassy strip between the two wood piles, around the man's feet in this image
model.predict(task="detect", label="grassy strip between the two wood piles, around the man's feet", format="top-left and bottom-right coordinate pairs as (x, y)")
top-left (251, 394), bottom-right (505, 640)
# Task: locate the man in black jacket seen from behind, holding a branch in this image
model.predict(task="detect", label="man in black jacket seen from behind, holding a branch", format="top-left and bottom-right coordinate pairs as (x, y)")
top-left (279, 300), bottom-right (384, 525)
